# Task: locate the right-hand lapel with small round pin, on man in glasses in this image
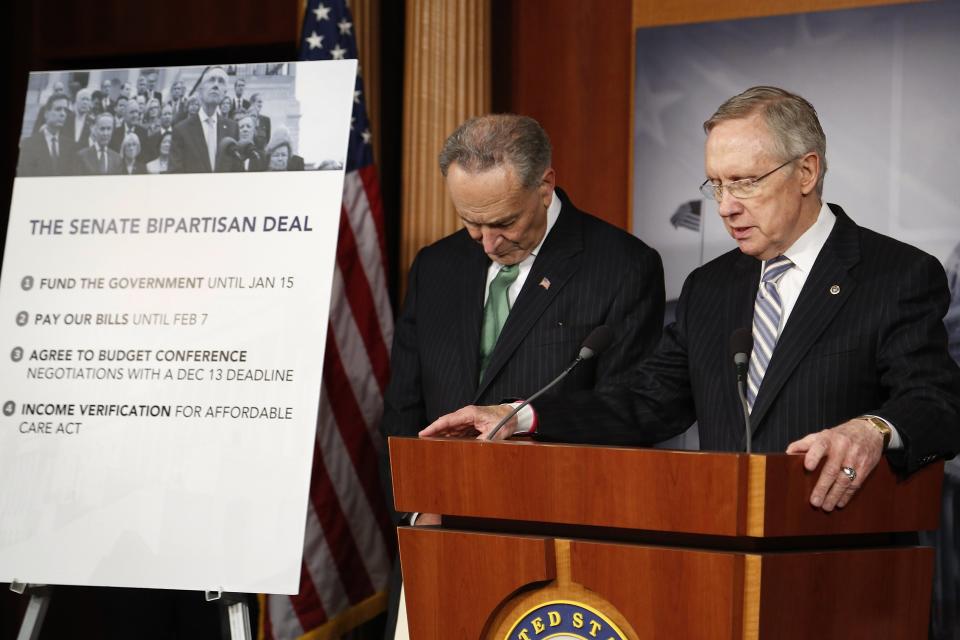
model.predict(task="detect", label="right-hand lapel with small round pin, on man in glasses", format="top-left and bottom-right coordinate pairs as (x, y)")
top-left (750, 205), bottom-right (860, 432)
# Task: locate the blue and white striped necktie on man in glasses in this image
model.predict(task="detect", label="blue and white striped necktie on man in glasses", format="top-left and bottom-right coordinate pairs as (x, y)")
top-left (747, 256), bottom-right (793, 411)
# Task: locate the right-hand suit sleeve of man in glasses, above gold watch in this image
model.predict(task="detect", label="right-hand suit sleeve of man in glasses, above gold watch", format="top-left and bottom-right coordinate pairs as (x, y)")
top-left (865, 255), bottom-right (960, 473)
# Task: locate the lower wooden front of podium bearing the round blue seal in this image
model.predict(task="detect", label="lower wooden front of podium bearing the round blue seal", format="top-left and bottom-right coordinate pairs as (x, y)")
top-left (400, 527), bottom-right (933, 640)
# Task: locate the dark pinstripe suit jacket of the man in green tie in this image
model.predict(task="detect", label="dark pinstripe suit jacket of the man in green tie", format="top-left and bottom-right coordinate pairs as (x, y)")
top-left (382, 189), bottom-right (664, 436)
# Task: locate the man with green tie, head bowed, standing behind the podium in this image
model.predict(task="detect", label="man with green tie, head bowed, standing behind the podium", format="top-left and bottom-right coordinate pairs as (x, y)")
top-left (382, 115), bottom-right (664, 637)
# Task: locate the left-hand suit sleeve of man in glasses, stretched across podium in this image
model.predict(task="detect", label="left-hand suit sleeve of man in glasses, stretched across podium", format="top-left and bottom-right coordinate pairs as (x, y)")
top-left (535, 264), bottom-right (696, 445)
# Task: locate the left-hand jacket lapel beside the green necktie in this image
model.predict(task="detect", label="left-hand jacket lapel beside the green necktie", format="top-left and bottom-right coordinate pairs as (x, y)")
top-left (457, 241), bottom-right (490, 396)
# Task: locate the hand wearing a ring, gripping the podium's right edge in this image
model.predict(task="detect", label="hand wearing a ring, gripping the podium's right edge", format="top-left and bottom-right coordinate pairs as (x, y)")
top-left (787, 418), bottom-right (883, 511)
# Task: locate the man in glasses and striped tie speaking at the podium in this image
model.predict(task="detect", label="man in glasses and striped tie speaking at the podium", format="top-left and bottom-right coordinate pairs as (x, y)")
top-left (423, 87), bottom-right (960, 511)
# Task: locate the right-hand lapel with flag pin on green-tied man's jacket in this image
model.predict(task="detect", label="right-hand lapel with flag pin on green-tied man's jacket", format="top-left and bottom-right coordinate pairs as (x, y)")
top-left (474, 198), bottom-right (583, 400)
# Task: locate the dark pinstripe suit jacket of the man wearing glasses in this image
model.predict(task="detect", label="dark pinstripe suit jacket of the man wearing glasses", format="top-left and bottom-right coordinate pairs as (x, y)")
top-left (536, 205), bottom-right (960, 471)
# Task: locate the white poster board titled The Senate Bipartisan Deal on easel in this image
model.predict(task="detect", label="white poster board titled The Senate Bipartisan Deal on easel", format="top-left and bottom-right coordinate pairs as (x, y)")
top-left (0, 60), bottom-right (356, 593)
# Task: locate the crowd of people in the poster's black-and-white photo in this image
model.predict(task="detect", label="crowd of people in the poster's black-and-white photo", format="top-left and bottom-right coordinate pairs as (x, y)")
top-left (17, 66), bottom-right (326, 177)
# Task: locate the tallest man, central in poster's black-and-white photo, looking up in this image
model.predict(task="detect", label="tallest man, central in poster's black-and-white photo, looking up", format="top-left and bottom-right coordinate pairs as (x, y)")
top-left (170, 67), bottom-right (238, 173)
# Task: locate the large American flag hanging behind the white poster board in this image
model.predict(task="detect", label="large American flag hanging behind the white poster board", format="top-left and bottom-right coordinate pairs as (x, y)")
top-left (260, 0), bottom-right (395, 640)
